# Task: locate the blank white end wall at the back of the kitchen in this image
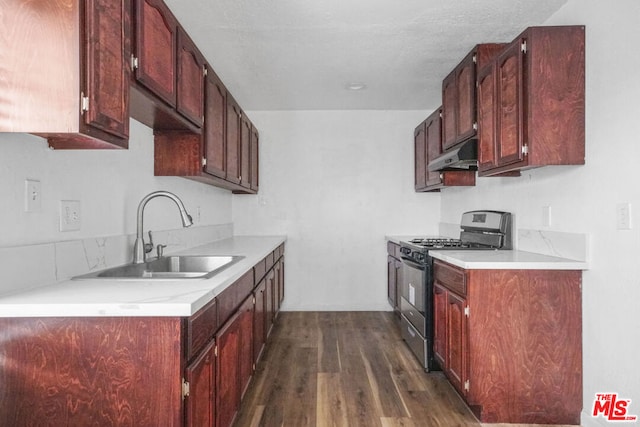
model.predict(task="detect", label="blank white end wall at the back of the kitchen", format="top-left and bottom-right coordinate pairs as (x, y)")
top-left (233, 111), bottom-right (440, 310)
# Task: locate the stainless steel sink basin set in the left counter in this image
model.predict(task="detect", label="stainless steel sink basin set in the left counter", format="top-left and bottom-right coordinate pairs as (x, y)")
top-left (73, 255), bottom-right (244, 280)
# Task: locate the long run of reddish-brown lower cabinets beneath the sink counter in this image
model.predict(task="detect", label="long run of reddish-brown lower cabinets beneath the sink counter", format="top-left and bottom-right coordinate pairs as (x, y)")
top-left (0, 245), bottom-right (284, 427)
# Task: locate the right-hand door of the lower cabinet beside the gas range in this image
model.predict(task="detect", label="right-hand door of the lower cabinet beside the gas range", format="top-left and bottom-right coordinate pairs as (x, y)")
top-left (445, 292), bottom-right (469, 396)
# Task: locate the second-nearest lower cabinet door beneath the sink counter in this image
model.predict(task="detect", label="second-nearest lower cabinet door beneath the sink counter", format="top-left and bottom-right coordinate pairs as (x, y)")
top-left (216, 312), bottom-right (240, 427)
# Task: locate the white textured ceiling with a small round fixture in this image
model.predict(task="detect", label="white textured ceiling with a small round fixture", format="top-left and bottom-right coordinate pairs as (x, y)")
top-left (165, 0), bottom-right (567, 110)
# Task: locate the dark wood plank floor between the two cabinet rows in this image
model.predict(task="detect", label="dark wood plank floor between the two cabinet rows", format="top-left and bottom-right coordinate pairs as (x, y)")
top-left (234, 312), bottom-right (580, 427)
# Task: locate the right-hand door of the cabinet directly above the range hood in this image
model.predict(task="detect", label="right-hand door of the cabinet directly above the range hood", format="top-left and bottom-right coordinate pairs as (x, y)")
top-left (456, 50), bottom-right (476, 142)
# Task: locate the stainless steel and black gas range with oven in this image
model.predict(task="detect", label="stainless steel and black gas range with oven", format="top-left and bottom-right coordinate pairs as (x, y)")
top-left (400, 210), bottom-right (513, 371)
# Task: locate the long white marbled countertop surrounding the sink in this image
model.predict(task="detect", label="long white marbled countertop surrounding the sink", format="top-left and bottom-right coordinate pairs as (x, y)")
top-left (0, 236), bottom-right (286, 317)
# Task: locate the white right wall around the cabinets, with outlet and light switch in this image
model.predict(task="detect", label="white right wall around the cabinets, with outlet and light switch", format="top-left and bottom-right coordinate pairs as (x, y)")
top-left (442, 0), bottom-right (640, 426)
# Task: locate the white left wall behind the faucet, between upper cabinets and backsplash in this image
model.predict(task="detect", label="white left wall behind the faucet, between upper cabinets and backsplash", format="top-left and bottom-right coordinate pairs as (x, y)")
top-left (0, 120), bottom-right (232, 248)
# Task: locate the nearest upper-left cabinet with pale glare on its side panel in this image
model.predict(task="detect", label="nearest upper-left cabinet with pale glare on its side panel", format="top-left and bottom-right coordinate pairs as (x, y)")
top-left (0, 0), bottom-right (130, 149)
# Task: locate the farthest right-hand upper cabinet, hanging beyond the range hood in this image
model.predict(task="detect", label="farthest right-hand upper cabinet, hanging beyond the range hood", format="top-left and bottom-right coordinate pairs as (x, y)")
top-left (414, 108), bottom-right (476, 191)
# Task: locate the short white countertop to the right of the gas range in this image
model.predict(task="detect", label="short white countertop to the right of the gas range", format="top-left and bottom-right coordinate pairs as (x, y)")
top-left (429, 250), bottom-right (588, 270)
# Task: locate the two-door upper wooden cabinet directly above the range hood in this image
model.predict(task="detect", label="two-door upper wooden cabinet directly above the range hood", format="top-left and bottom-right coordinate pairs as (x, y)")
top-left (442, 43), bottom-right (504, 150)
